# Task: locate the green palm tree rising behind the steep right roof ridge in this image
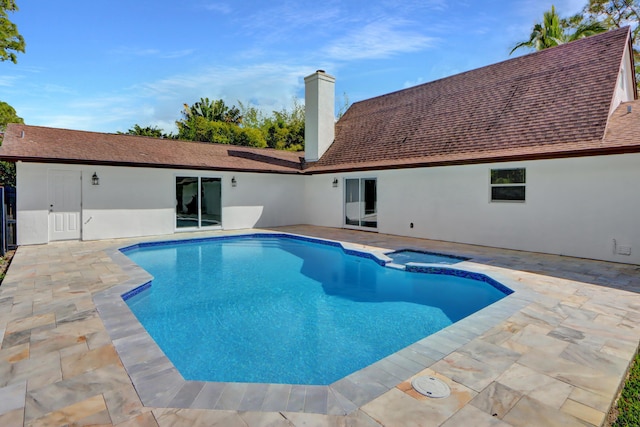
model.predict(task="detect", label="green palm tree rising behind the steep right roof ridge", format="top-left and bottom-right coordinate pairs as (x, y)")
top-left (509, 5), bottom-right (607, 55)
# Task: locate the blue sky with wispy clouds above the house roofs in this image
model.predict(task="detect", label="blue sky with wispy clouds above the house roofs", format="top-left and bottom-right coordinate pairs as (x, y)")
top-left (0, 0), bottom-right (586, 132)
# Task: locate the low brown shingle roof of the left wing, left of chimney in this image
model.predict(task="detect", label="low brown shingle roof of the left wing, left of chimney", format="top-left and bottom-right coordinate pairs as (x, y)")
top-left (0, 124), bottom-right (303, 173)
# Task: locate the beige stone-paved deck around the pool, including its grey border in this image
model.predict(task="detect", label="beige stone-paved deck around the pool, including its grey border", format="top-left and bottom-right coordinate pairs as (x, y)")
top-left (0, 226), bottom-right (640, 426)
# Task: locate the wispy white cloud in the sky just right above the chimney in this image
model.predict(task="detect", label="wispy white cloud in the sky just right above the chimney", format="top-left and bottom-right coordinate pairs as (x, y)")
top-left (327, 20), bottom-right (436, 61)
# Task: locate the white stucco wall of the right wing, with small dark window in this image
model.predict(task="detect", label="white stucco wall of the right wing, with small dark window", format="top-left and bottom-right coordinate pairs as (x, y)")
top-left (306, 154), bottom-right (640, 264)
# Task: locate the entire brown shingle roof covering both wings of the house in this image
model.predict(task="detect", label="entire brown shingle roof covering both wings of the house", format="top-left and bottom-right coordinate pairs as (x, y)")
top-left (0, 28), bottom-right (640, 174)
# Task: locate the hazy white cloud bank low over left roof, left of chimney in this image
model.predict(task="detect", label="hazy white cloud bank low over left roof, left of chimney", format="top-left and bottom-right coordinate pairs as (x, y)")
top-left (52, 63), bottom-right (315, 132)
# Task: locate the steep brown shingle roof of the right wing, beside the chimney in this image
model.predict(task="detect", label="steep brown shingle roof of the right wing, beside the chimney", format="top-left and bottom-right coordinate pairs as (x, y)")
top-left (308, 28), bottom-right (637, 172)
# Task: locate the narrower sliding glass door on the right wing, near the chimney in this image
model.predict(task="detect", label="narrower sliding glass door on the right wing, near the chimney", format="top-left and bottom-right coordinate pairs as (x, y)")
top-left (344, 178), bottom-right (378, 228)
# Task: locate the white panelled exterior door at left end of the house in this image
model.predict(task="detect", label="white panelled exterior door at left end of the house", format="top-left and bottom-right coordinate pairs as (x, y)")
top-left (49, 170), bottom-right (82, 241)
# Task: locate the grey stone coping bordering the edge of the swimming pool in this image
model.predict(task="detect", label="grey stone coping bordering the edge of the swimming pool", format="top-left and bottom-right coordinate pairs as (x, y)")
top-left (93, 232), bottom-right (535, 415)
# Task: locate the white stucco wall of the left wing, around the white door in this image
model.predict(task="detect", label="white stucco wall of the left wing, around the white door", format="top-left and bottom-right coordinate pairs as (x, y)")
top-left (17, 162), bottom-right (304, 245)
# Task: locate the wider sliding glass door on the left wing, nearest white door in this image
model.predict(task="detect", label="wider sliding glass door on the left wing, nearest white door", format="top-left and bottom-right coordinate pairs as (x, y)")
top-left (176, 176), bottom-right (222, 229)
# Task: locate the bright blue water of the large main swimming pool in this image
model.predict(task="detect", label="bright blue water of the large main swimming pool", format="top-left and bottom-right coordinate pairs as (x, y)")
top-left (124, 236), bottom-right (510, 385)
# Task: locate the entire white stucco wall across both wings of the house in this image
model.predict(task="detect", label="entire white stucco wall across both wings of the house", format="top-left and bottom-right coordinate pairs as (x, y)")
top-left (17, 154), bottom-right (640, 264)
